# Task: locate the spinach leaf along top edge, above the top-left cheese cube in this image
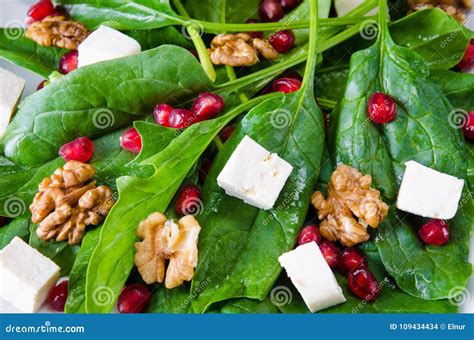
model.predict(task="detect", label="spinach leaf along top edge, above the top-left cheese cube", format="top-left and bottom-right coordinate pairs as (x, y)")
top-left (59, 0), bottom-right (180, 30)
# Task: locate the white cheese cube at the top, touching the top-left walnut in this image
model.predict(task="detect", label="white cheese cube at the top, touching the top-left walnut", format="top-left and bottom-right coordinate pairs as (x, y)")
top-left (77, 26), bottom-right (141, 67)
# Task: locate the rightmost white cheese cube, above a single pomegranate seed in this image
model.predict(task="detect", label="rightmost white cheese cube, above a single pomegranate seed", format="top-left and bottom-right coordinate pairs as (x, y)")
top-left (397, 161), bottom-right (464, 219)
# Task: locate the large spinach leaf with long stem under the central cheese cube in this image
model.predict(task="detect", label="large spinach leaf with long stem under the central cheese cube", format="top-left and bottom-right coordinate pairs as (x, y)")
top-left (191, 1), bottom-right (324, 313)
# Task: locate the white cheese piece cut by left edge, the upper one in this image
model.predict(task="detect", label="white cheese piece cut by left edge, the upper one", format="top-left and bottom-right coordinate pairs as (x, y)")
top-left (0, 68), bottom-right (25, 137)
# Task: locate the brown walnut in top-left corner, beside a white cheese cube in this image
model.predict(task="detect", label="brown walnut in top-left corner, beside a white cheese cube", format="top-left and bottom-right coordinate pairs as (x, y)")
top-left (26, 15), bottom-right (88, 50)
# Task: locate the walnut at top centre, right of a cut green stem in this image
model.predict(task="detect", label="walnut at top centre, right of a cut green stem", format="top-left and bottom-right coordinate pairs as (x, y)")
top-left (208, 33), bottom-right (278, 66)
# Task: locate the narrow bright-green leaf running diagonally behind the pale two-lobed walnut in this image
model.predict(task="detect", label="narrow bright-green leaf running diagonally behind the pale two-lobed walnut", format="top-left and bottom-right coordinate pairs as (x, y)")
top-left (86, 94), bottom-right (276, 313)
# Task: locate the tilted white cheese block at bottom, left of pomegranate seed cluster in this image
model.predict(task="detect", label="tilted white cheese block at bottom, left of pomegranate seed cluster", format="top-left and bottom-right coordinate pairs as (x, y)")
top-left (278, 242), bottom-right (346, 313)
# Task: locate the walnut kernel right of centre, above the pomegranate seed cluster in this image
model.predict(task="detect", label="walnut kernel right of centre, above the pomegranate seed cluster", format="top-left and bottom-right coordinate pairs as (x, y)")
top-left (311, 165), bottom-right (388, 246)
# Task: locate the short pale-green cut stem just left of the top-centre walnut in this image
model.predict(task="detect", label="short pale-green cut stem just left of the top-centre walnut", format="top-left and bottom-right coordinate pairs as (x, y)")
top-left (173, 0), bottom-right (216, 82)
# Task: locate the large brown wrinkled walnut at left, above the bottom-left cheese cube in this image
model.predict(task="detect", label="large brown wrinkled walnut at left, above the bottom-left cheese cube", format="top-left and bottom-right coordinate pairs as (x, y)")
top-left (30, 161), bottom-right (114, 244)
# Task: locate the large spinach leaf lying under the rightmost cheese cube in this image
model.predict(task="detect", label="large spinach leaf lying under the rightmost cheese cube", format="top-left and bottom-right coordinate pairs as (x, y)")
top-left (329, 1), bottom-right (471, 299)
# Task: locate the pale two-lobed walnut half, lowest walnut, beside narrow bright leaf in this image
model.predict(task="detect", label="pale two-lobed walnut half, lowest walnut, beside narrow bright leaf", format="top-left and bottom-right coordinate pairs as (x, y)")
top-left (135, 212), bottom-right (201, 289)
